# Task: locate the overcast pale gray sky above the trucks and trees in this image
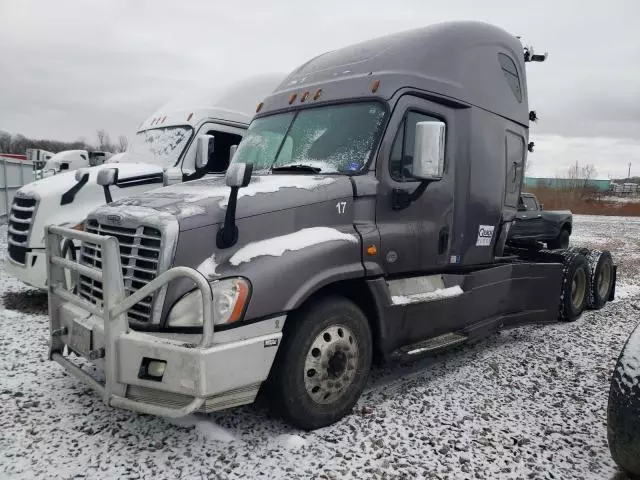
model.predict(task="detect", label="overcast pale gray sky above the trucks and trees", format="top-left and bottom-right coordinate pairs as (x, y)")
top-left (0, 0), bottom-right (640, 178)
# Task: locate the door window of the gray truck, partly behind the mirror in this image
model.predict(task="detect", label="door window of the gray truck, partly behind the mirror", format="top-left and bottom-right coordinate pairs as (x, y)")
top-left (389, 111), bottom-right (441, 182)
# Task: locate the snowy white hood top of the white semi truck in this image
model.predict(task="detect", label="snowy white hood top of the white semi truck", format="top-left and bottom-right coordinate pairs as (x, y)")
top-left (19, 163), bottom-right (162, 198)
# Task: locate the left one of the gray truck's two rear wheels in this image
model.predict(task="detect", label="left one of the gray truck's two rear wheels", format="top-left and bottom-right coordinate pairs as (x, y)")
top-left (558, 250), bottom-right (591, 322)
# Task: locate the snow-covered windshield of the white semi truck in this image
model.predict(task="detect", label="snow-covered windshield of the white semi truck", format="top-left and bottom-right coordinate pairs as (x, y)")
top-left (120, 126), bottom-right (193, 167)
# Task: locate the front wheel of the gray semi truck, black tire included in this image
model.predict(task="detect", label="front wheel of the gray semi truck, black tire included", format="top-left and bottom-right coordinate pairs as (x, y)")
top-left (267, 296), bottom-right (373, 430)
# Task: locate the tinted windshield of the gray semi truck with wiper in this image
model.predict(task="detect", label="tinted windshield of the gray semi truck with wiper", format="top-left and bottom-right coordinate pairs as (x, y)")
top-left (233, 102), bottom-right (386, 173)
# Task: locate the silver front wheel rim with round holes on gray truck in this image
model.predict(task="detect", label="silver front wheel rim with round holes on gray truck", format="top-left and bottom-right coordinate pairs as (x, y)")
top-left (303, 325), bottom-right (359, 404)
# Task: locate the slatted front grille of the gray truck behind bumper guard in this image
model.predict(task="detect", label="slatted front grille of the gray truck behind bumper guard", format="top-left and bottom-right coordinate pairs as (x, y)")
top-left (78, 219), bottom-right (162, 323)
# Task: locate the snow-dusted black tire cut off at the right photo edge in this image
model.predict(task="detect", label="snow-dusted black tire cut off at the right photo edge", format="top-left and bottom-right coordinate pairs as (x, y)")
top-left (607, 327), bottom-right (640, 478)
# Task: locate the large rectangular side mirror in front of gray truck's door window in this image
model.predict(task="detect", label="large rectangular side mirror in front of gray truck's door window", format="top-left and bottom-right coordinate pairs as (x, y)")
top-left (412, 122), bottom-right (446, 180)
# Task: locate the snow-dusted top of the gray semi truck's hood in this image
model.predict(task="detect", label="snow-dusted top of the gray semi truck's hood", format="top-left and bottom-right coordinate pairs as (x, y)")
top-left (109, 174), bottom-right (353, 231)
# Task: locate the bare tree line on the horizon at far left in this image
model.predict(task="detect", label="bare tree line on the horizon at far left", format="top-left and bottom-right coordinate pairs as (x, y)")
top-left (0, 129), bottom-right (129, 155)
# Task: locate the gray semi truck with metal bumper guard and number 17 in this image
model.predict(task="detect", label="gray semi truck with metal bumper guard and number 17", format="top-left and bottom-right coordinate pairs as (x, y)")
top-left (47, 22), bottom-right (615, 429)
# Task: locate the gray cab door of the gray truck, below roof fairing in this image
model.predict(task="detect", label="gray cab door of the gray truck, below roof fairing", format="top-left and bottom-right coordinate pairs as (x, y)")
top-left (376, 95), bottom-right (455, 276)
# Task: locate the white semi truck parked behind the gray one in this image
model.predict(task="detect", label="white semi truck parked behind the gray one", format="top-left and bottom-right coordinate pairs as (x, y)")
top-left (6, 74), bottom-right (284, 289)
